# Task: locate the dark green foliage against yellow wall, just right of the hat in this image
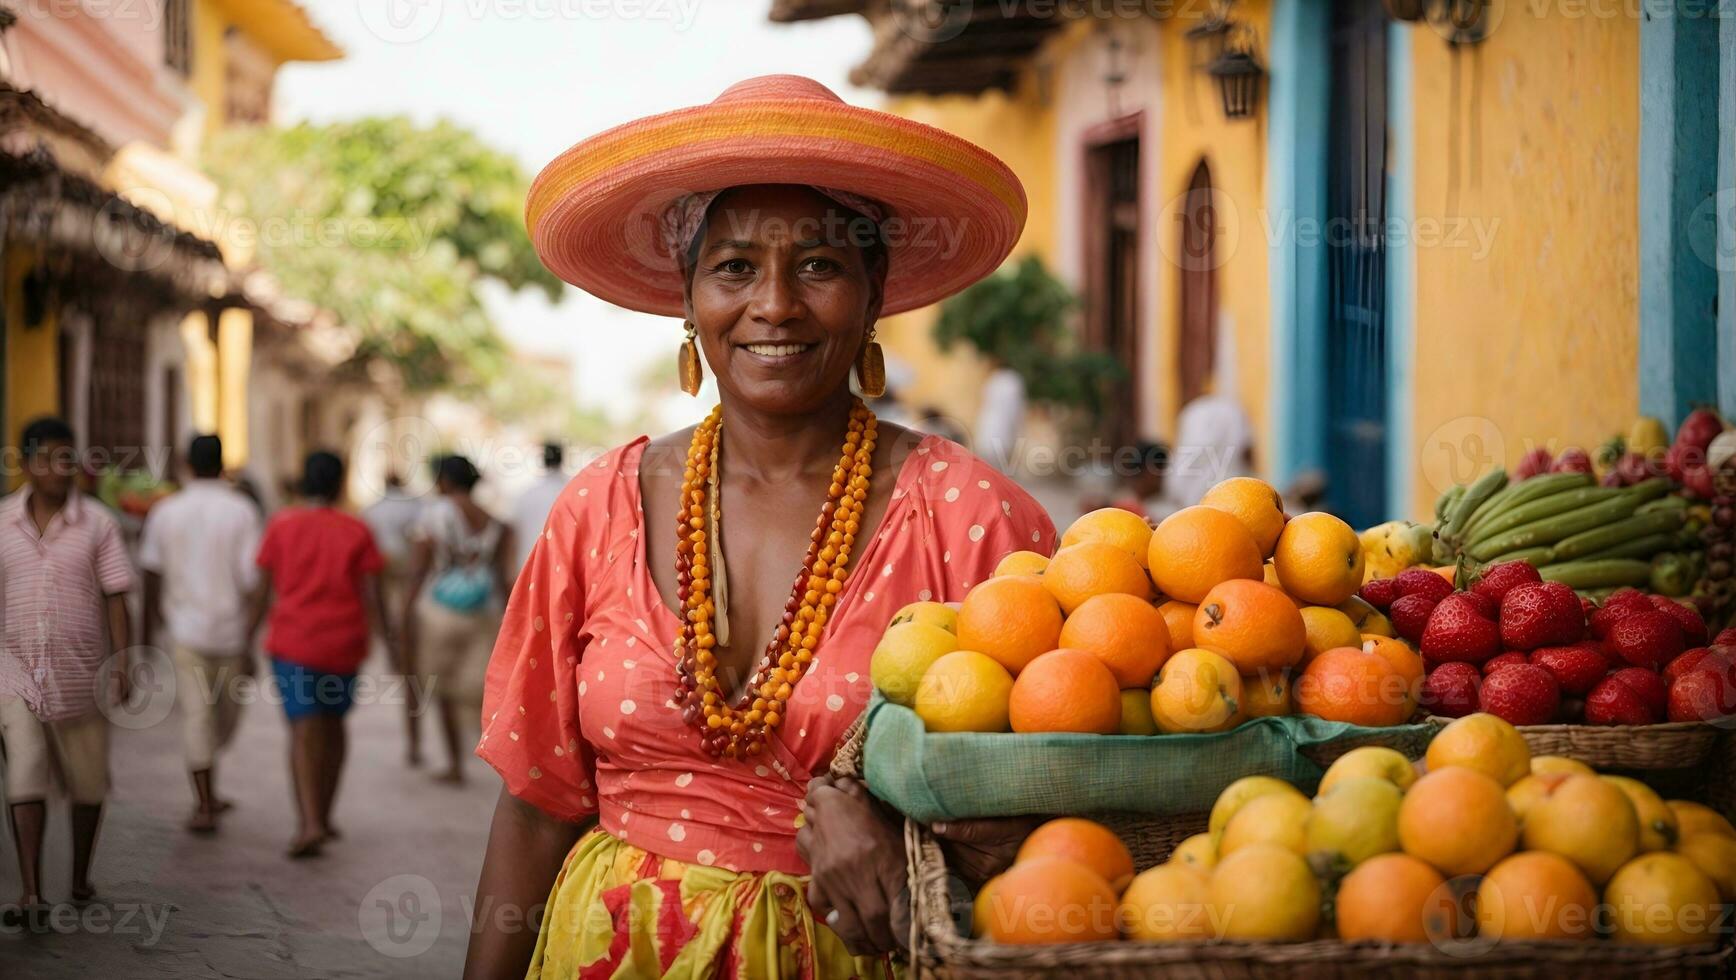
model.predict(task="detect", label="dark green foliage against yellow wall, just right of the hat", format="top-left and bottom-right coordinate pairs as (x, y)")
top-left (934, 257), bottom-right (1127, 423)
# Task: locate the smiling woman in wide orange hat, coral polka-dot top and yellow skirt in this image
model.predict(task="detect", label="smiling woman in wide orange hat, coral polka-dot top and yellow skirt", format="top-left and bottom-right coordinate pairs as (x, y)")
top-left (465, 76), bottom-right (1054, 980)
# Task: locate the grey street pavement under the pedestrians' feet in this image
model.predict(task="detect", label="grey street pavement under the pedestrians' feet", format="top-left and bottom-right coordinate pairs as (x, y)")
top-left (0, 645), bottom-right (500, 980)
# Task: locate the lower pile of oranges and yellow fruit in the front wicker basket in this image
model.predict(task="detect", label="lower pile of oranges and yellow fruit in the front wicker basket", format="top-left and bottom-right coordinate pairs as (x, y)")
top-left (974, 715), bottom-right (1736, 945)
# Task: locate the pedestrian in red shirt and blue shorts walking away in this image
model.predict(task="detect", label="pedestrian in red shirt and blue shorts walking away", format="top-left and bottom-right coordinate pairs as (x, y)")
top-left (248, 453), bottom-right (394, 857)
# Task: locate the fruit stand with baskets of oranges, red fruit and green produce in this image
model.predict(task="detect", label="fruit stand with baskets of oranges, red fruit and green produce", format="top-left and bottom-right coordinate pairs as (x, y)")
top-left (861, 413), bottom-right (1736, 978)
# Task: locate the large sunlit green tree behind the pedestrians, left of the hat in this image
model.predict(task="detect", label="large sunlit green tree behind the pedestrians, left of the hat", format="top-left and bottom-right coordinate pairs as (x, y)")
top-left (205, 118), bottom-right (561, 394)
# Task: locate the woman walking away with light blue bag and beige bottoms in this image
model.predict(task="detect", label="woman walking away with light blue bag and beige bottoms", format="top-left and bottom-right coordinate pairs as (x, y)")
top-left (401, 456), bottom-right (517, 784)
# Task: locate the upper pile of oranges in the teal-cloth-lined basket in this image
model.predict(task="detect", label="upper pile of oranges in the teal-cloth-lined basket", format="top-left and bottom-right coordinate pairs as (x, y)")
top-left (871, 477), bottom-right (1424, 735)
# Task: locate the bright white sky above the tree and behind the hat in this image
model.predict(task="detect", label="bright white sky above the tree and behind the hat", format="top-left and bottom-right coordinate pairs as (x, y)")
top-left (276, 0), bottom-right (877, 425)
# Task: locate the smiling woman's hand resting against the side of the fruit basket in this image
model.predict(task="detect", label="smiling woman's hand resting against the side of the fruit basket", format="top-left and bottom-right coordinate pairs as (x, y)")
top-left (795, 775), bottom-right (910, 956)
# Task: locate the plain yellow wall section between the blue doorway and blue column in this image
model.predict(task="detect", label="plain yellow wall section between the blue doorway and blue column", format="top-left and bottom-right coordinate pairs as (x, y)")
top-left (1411, 7), bottom-right (1639, 517)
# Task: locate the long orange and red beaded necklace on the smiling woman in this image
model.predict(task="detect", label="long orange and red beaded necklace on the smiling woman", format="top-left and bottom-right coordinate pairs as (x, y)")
top-left (675, 399), bottom-right (877, 758)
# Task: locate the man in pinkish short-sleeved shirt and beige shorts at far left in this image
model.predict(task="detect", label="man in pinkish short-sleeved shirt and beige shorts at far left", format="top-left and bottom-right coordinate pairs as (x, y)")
top-left (0, 418), bottom-right (134, 928)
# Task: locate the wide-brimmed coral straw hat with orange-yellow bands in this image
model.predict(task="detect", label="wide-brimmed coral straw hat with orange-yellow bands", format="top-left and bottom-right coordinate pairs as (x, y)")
top-left (524, 75), bottom-right (1026, 317)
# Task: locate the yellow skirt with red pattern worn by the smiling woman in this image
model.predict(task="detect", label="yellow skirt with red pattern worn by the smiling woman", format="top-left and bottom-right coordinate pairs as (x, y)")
top-left (526, 829), bottom-right (899, 980)
